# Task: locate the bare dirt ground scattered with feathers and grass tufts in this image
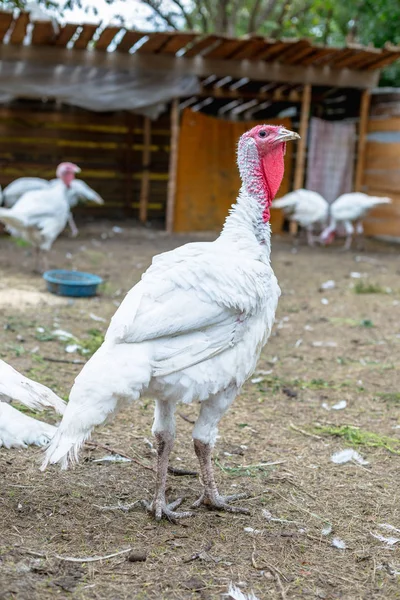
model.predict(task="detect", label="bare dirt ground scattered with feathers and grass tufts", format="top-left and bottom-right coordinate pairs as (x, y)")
top-left (0, 222), bottom-right (400, 600)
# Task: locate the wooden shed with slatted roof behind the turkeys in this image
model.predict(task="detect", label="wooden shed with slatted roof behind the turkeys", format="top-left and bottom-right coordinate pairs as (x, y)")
top-left (0, 13), bottom-right (400, 233)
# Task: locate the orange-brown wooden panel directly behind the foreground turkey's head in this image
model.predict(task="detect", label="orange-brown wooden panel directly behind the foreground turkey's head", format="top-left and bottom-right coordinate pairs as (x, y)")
top-left (173, 108), bottom-right (293, 232)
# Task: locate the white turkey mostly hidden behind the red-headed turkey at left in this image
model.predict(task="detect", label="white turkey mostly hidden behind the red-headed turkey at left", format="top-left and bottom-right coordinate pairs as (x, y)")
top-left (0, 172), bottom-right (104, 237)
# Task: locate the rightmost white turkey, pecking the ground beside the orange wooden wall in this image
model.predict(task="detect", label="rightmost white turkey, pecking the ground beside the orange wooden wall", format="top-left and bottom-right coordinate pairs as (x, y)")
top-left (320, 192), bottom-right (392, 250)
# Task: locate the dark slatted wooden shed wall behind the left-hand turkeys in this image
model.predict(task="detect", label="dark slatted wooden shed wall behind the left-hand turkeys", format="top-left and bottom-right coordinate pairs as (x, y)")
top-left (0, 101), bottom-right (170, 221)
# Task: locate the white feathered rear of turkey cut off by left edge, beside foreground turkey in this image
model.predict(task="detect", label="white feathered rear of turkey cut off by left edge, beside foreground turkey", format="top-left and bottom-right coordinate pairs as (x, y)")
top-left (0, 360), bottom-right (66, 448)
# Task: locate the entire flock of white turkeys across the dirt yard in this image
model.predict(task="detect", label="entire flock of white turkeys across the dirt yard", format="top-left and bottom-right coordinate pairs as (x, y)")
top-left (0, 125), bottom-right (390, 521)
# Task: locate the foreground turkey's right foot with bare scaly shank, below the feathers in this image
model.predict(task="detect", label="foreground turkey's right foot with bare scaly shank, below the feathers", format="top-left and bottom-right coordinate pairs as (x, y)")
top-left (192, 439), bottom-right (250, 514)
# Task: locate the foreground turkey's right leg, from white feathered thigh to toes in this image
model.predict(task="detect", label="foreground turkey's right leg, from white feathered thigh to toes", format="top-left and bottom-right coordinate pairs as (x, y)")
top-left (192, 390), bottom-right (250, 514)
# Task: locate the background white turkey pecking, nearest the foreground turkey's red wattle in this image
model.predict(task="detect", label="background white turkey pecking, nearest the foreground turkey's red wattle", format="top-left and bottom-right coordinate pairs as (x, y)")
top-left (272, 189), bottom-right (329, 246)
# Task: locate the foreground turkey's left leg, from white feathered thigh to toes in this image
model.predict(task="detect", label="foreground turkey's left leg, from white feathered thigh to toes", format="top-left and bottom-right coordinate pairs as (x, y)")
top-left (143, 400), bottom-right (192, 521)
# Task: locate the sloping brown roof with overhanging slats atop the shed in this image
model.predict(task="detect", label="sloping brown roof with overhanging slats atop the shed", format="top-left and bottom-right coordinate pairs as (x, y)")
top-left (0, 12), bottom-right (400, 71)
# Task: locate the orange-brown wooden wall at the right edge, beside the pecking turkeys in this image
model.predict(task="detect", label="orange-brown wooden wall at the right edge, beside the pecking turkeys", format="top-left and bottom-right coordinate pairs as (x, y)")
top-left (362, 117), bottom-right (400, 240)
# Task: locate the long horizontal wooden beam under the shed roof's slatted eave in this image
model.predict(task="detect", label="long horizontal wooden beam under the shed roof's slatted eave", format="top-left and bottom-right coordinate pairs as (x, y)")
top-left (2, 45), bottom-right (379, 89)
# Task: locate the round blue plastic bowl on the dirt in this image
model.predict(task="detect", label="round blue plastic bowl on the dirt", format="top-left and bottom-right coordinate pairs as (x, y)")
top-left (43, 269), bottom-right (103, 298)
